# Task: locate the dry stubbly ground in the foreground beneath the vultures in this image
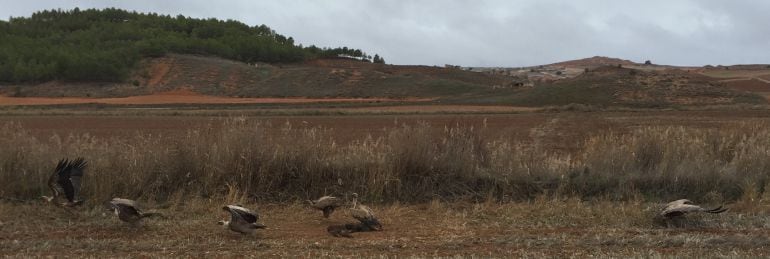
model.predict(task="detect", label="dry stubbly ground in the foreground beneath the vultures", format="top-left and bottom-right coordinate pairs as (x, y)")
top-left (0, 199), bottom-right (770, 258)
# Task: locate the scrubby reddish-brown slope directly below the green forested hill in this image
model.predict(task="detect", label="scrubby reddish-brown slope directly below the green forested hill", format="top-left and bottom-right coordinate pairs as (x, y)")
top-left (6, 54), bottom-right (511, 98)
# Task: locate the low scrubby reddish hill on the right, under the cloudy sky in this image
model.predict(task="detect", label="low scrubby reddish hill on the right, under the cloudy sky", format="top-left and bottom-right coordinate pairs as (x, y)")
top-left (448, 66), bottom-right (767, 107)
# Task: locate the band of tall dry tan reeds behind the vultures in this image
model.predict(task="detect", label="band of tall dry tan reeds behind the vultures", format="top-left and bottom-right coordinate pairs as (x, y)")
top-left (0, 119), bottom-right (770, 205)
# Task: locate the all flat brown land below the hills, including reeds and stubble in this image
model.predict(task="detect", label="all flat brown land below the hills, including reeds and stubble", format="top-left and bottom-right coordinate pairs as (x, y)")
top-left (0, 110), bottom-right (770, 257)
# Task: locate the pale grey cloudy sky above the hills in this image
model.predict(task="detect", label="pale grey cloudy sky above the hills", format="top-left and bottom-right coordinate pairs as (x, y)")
top-left (0, 0), bottom-right (770, 66)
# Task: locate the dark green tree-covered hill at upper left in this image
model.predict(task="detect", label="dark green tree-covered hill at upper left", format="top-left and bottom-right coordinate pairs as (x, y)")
top-left (0, 8), bottom-right (384, 83)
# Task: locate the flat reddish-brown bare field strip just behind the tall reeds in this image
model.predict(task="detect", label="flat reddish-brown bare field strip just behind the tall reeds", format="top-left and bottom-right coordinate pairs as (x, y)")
top-left (6, 106), bottom-right (770, 151)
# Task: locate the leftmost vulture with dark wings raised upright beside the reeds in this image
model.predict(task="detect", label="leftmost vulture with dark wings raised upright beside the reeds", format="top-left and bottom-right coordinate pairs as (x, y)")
top-left (43, 157), bottom-right (87, 207)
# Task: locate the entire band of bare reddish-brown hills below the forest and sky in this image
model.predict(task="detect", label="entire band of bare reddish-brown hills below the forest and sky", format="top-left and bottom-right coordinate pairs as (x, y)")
top-left (0, 54), bottom-right (766, 107)
